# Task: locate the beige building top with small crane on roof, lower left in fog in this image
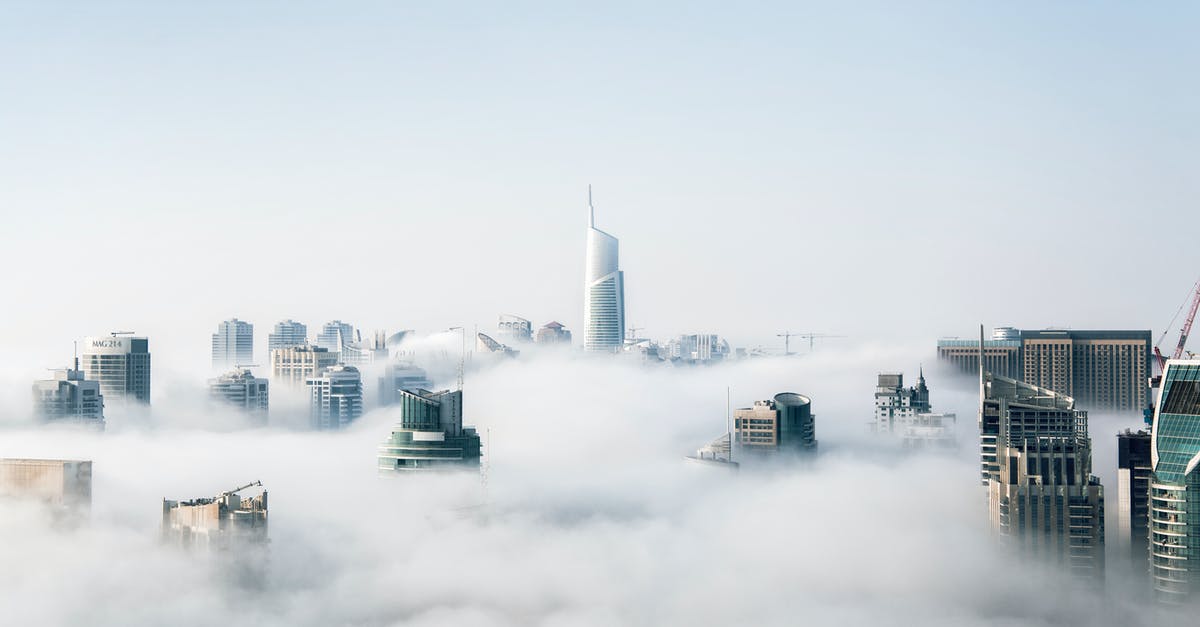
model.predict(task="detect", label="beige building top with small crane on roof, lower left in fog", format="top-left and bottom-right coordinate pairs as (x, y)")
top-left (162, 482), bottom-right (268, 553)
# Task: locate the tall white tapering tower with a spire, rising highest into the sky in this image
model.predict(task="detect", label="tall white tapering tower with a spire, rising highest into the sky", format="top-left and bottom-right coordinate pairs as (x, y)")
top-left (583, 187), bottom-right (625, 353)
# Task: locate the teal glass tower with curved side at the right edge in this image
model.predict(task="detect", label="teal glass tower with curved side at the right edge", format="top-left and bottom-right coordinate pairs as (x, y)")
top-left (1150, 359), bottom-right (1200, 604)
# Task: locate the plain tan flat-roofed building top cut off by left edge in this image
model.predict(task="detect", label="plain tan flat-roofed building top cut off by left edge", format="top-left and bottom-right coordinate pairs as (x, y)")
top-left (0, 459), bottom-right (91, 521)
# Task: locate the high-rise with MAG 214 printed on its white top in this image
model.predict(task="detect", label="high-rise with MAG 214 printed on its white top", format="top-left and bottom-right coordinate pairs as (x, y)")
top-left (83, 333), bottom-right (150, 405)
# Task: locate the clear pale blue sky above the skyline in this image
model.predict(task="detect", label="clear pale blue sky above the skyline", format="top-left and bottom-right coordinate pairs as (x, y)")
top-left (0, 1), bottom-right (1200, 365)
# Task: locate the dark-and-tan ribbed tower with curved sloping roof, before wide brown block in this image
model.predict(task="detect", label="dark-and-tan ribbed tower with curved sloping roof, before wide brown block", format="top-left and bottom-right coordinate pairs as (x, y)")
top-left (979, 372), bottom-right (1104, 579)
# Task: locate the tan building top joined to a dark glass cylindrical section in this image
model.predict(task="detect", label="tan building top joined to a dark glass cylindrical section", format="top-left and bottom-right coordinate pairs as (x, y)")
top-left (733, 392), bottom-right (817, 455)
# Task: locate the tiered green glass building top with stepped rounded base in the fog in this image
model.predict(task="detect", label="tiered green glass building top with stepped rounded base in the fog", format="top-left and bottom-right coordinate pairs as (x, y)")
top-left (378, 389), bottom-right (481, 472)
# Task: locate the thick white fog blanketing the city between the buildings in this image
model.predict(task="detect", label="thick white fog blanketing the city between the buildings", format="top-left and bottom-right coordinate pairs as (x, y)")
top-left (0, 345), bottom-right (1148, 626)
